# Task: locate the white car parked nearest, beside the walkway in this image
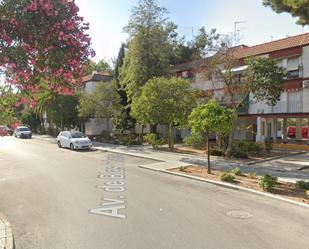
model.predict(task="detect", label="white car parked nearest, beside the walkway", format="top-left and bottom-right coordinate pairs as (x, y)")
top-left (57, 131), bottom-right (92, 150)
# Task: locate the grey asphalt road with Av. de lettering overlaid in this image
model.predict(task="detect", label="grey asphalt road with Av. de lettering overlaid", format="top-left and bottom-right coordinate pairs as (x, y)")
top-left (0, 137), bottom-right (309, 249)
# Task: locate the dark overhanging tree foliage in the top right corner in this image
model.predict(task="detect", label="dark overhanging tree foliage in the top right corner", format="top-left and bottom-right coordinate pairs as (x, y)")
top-left (263, 0), bottom-right (309, 25)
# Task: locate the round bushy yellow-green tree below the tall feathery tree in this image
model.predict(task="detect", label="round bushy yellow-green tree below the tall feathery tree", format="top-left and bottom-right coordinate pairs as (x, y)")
top-left (132, 77), bottom-right (196, 150)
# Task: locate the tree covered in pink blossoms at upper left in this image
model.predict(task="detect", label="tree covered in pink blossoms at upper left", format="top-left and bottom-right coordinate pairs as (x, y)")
top-left (0, 0), bottom-right (95, 106)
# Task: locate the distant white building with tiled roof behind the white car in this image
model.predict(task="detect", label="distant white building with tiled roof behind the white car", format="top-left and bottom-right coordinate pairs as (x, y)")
top-left (82, 71), bottom-right (113, 136)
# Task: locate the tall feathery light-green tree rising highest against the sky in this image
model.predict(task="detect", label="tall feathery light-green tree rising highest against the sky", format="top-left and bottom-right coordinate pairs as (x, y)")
top-left (120, 0), bottom-right (171, 101)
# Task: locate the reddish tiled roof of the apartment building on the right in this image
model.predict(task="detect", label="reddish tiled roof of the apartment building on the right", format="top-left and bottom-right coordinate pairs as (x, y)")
top-left (237, 33), bottom-right (309, 58)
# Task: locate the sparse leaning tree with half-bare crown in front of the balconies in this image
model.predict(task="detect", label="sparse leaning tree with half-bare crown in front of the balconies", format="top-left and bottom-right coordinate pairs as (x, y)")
top-left (206, 43), bottom-right (285, 156)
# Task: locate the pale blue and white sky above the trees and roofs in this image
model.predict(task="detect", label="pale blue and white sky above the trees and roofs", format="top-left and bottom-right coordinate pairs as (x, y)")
top-left (75, 0), bottom-right (309, 63)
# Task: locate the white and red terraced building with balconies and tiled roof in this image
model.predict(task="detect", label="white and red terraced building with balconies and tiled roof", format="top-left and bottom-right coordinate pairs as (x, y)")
top-left (175, 33), bottom-right (309, 144)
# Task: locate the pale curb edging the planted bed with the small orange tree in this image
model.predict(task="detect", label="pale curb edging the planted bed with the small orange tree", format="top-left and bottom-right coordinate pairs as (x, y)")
top-left (138, 165), bottom-right (309, 209)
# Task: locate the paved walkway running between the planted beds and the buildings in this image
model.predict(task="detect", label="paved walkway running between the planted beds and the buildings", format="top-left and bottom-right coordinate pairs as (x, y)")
top-left (33, 135), bottom-right (309, 182)
